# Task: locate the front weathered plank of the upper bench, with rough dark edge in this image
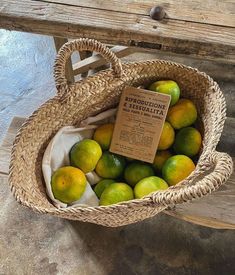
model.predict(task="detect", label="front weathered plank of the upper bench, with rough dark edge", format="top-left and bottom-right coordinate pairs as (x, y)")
top-left (0, 0), bottom-right (235, 63)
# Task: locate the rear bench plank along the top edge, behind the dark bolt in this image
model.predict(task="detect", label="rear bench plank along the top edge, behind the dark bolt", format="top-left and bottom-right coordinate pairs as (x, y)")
top-left (47, 0), bottom-right (235, 27)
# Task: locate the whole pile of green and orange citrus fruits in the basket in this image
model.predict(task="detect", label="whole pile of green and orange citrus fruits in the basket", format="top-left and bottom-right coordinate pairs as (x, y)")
top-left (51, 80), bottom-right (202, 205)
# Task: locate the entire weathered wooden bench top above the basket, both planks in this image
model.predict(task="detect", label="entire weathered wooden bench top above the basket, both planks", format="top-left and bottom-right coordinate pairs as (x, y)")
top-left (0, 0), bottom-right (235, 63)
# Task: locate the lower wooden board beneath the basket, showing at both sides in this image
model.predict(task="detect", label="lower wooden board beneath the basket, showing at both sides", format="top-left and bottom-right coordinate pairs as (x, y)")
top-left (0, 117), bottom-right (235, 229)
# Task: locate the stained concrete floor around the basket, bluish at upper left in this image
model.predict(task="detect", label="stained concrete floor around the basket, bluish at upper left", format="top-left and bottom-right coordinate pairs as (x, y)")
top-left (0, 30), bottom-right (235, 275)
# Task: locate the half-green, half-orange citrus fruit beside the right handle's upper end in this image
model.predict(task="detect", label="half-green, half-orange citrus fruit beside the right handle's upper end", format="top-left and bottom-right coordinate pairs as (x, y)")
top-left (162, 155), bottom-right (195, 185)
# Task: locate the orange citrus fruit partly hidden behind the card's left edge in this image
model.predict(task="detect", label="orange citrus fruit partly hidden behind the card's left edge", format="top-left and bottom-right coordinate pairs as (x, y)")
top-left (93, 123), bottom-right (114, 150)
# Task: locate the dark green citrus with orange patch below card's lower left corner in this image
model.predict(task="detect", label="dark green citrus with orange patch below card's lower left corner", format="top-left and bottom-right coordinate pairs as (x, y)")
top-left (95, 152), bottom-right (126, 179)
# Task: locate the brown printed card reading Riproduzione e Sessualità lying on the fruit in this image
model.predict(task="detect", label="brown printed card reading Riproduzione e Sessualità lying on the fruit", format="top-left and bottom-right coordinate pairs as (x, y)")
top-left (110, 87), bottom-right (171, 163)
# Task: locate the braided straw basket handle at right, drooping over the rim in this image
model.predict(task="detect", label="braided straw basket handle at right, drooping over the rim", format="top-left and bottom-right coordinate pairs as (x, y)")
top-left (151, 151), bottom-right (233, 206)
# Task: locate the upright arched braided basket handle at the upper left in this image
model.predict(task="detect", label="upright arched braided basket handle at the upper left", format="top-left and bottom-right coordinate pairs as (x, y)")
top-left (54, 38), bottom-right (122, 94)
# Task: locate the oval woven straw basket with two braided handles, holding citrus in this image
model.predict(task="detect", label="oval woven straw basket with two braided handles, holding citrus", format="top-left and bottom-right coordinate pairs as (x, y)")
top-left (9, 39), bottom-right (233, 227)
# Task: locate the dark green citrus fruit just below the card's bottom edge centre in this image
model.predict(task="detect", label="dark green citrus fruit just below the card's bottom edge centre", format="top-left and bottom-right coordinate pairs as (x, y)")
top-left (124, 162), bottom-right (154, 186)
